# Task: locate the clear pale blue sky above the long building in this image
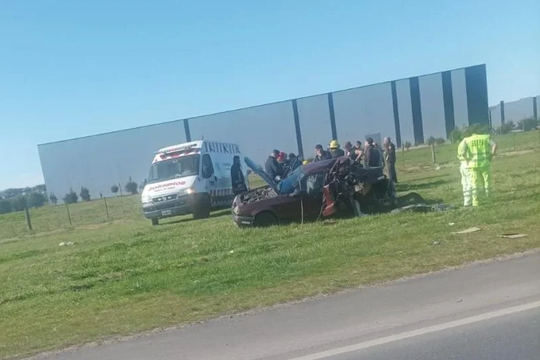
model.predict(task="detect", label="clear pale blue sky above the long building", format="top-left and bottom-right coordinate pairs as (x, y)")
top-left (0, 0), bottom-right (540, 189)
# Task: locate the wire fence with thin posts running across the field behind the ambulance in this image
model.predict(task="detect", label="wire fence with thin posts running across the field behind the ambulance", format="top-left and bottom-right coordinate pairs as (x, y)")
top-left (0, 130), bottom-right (540, 239)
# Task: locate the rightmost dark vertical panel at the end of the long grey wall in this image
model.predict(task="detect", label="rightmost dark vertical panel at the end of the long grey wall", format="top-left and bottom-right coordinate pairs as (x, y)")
top-left (465, 64), bottom-right (489, 125)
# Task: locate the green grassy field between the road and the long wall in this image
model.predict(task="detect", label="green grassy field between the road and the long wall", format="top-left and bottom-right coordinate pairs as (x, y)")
top-left (0, 132), bottom-right (540, 358)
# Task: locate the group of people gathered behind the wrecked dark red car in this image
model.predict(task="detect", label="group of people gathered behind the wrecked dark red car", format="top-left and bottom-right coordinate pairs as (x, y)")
top-left (313, 137), bottom-right (397, 182)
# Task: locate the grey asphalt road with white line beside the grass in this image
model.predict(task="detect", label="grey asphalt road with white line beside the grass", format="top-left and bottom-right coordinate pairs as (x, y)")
top-left (32, 253), bottom-right (540, 360)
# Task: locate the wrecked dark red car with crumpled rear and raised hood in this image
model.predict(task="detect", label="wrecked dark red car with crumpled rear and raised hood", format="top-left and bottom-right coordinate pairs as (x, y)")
top-left (232, 157), bottom-right (414, 227)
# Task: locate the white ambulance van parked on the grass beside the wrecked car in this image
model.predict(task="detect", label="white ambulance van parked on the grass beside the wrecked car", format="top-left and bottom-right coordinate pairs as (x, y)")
top-left (141, 140), bottom-right (248, 225)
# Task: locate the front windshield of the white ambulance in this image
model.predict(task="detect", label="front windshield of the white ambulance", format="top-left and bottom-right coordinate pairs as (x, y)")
top-left (148, 155), bottom-right (199, 183)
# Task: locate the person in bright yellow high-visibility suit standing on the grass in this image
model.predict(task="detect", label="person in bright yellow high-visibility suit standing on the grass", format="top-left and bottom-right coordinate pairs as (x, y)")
top-left (458, 133), bottom-right (497, 206)
